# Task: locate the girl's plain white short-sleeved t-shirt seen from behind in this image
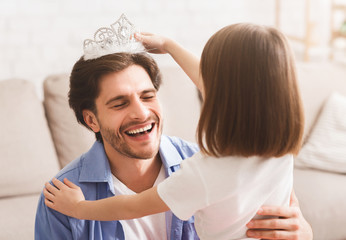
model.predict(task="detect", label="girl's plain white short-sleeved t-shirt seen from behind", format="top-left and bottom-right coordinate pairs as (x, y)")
top-left (158, 153), bottom-right (293, 240)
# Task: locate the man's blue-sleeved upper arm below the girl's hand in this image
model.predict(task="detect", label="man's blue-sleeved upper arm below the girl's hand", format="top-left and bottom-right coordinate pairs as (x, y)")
top-left (35, 190), bottom-right (73, 240)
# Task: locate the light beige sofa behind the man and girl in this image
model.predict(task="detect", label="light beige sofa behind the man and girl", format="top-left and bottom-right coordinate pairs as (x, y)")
top-left (0, 64), bottom-right (346, 240)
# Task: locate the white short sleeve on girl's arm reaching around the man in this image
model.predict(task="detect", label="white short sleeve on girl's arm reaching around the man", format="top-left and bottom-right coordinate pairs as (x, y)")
top-left (157, 153), bottom-right (208, 220)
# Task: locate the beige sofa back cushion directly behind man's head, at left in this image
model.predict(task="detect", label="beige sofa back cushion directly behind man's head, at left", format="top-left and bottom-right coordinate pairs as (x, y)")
top-left (44, 74), bottom-right (95, 167)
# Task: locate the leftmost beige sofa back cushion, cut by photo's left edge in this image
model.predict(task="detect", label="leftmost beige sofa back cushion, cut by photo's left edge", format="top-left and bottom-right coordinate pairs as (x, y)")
top-left (0, 79), bottom-right (59, 197)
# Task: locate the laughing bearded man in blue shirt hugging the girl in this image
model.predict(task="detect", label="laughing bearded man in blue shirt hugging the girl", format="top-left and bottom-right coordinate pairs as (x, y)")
top-left (35, 53), bottom-right (312, 239)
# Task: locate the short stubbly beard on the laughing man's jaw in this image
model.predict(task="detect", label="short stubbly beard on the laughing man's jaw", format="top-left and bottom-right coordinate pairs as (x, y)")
top-left (100, 116), bottom-right (162, 159)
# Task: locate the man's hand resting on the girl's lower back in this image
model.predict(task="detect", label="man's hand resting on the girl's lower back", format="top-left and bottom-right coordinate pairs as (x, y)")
top-left (246, 191), bottom-right (313, 240)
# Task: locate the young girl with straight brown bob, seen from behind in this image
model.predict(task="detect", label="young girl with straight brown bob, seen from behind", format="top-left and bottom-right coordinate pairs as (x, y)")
top-left (44, 24), bottom-right (304, 239)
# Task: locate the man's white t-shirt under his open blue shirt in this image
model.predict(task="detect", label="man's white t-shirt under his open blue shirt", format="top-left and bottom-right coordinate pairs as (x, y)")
top-left (113, 167), bottom-right (167, 240)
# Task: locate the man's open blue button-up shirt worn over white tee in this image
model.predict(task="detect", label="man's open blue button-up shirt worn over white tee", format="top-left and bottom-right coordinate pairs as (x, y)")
top-left (35, 136), bottom-right (199, 240)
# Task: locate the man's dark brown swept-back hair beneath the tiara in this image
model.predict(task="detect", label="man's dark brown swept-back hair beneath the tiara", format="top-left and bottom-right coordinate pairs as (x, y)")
top-left (68, 53), bottom-right (161, 142)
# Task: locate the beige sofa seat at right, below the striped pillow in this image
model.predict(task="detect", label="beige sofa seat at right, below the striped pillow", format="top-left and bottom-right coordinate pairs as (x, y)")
top-left (294, 168), bottom-right (346, 240)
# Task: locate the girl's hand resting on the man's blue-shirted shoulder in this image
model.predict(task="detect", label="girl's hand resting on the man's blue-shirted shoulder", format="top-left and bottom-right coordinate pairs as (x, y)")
top-left (43, 178), bottom-right (85, 218)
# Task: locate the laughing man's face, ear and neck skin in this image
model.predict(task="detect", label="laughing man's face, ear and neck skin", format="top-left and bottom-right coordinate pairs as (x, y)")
top-left (84, 62), bottom-right (162, 192)
